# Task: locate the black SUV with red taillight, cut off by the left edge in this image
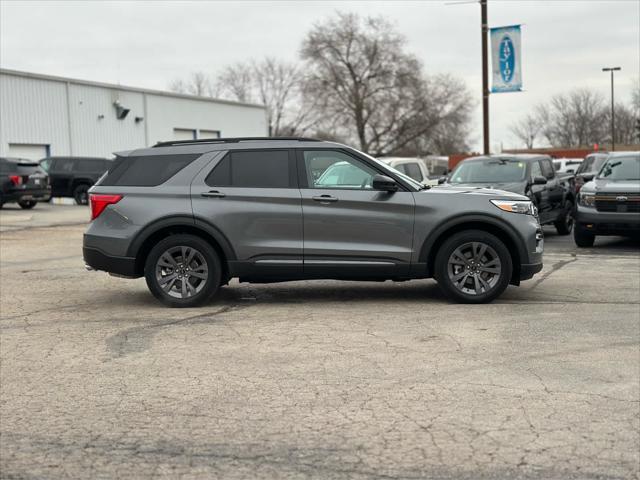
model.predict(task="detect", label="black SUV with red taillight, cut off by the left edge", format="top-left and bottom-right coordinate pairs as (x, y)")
top-left (0, 157), bottom-right (51, 209)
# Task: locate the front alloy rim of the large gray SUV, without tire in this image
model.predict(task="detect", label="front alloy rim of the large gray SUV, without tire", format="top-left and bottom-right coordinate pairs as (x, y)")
top-left (447, 242), bottom-right (502, 295)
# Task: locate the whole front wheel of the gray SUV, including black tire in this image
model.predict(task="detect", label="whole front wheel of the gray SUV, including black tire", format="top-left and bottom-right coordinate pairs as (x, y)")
top-left (435, 230), bottom-right (513, 303)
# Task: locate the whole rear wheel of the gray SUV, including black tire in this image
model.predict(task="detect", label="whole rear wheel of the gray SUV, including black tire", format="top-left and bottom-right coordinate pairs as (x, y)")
top-left (144, 234), bottom-right (222, 308)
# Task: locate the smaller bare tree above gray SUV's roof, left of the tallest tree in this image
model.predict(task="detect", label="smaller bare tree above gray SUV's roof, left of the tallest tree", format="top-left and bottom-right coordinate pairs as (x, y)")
top-left (216, 57), bottom-right (316, 136)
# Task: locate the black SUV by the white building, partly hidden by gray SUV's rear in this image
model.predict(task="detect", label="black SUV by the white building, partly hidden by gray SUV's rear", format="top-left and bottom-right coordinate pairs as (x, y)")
top-left (40, 157), bottom-right (112, 205)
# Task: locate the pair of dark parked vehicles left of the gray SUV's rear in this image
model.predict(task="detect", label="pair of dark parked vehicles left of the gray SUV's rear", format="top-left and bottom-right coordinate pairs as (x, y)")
top-left (0, 157), bottom-right (113, 209)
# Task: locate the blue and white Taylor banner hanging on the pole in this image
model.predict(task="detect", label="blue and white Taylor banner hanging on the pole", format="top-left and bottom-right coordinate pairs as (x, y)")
top-left (490, 25), bottom-right (522, 93)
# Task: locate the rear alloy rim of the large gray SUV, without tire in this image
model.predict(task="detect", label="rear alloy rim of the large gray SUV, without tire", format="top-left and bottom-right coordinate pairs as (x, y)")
top-left (155, 246), bottom-right (209, 298)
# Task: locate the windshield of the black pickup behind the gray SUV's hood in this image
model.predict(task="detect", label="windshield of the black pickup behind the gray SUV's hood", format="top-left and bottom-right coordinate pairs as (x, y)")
top-left (449, 158), bottom-right (527, 183)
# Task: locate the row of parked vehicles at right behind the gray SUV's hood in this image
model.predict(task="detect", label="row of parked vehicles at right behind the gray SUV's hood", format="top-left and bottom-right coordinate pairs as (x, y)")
top-left (439, 152), bottom-right (640, 247)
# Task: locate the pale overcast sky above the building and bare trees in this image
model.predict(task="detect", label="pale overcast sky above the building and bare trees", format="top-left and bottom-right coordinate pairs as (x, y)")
top-left (0, 0), bottom-right (640, 151)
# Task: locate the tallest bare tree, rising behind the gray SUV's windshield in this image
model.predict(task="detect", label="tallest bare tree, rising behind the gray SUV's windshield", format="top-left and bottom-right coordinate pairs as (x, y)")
top-left (302, 13), bottom-right (472, 155)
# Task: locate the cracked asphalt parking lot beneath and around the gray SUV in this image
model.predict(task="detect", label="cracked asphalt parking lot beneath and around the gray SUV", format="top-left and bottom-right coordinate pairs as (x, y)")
top-left (0, 205), bottom-right (640, 479)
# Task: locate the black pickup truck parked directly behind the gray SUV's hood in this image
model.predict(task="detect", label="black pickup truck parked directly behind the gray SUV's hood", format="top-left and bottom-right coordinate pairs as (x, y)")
top-left (440, 155), bottom-right (575, 235)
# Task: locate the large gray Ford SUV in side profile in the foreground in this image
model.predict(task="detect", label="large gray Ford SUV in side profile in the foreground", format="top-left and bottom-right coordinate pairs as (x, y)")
top-left (83, 138), bottom-right (543, 307)
